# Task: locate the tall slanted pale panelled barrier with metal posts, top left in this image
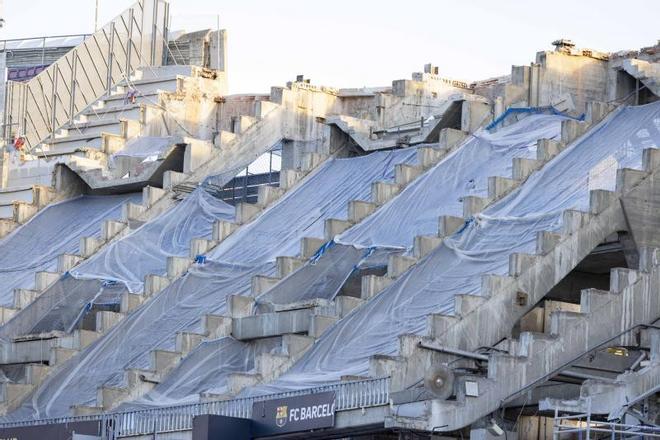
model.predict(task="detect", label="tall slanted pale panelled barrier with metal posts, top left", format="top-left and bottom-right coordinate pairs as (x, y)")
top-left (3, 0), bottom-right (169, 151)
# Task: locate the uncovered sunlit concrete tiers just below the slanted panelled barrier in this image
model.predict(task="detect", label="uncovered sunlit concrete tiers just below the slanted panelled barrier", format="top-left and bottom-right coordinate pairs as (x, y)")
top-left (0, 66), bottom-right (223, 237)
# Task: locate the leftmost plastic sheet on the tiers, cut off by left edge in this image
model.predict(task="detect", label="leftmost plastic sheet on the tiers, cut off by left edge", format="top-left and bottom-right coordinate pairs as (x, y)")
top-left (0, 194), bottom-right (140, 306)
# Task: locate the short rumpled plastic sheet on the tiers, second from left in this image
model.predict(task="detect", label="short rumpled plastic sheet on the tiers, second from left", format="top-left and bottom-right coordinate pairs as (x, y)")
top-left (0, 189), bottom-right (234, 338)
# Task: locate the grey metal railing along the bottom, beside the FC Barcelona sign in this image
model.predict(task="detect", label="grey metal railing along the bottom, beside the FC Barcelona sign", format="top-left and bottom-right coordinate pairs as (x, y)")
top-left (0, 377), bottom-right (390, 439)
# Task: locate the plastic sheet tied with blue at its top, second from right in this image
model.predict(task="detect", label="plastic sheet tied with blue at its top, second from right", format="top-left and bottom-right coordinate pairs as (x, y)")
top-left (259, 115), bottom-right (566, 310)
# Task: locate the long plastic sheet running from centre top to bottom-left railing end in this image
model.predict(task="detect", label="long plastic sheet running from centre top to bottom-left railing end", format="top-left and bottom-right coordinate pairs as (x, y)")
top-left (9, 149), bottom-right (415, 419)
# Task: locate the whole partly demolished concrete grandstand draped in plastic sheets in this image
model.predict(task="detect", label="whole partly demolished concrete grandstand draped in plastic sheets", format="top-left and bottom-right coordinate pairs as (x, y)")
top-left (0, 0), bottom-right (660, 440)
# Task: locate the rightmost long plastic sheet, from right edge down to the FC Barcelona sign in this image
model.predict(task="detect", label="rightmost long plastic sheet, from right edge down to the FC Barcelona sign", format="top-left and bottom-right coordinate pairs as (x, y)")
top-left (246, 103), bottom-right (660, 394)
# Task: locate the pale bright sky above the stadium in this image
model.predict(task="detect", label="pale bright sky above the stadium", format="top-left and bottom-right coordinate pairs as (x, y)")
top-left (0, 0), bottom-right (660, 93)
